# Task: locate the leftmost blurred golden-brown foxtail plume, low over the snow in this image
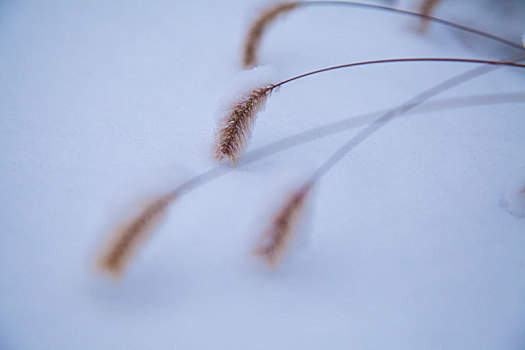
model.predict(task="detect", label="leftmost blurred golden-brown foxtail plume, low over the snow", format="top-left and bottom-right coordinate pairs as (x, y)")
top-left (97, 194), bottom-right (175, 279)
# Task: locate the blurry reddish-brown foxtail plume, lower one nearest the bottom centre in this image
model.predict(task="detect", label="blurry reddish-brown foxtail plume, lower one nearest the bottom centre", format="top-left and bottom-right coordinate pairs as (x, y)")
top-left (253, 186), bottom-right (311, 268)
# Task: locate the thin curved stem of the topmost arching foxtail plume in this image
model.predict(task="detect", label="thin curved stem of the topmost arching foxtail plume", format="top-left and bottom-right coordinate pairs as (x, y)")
top-left (300, 1), bottom-right (525, 51)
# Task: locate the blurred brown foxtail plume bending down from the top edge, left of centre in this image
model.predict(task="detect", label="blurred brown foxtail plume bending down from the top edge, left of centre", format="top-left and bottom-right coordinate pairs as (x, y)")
top-left (242, 1), bottom-right (300, 68)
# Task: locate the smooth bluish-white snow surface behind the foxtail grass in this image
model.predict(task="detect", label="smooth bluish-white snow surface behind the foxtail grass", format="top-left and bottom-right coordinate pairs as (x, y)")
top-left (0, 0), bottom-right (525, 349)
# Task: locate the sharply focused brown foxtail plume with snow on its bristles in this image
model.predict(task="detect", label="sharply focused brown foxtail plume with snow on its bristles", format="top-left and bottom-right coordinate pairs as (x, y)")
top-left (215, 85), bottom-right (274, 164)
